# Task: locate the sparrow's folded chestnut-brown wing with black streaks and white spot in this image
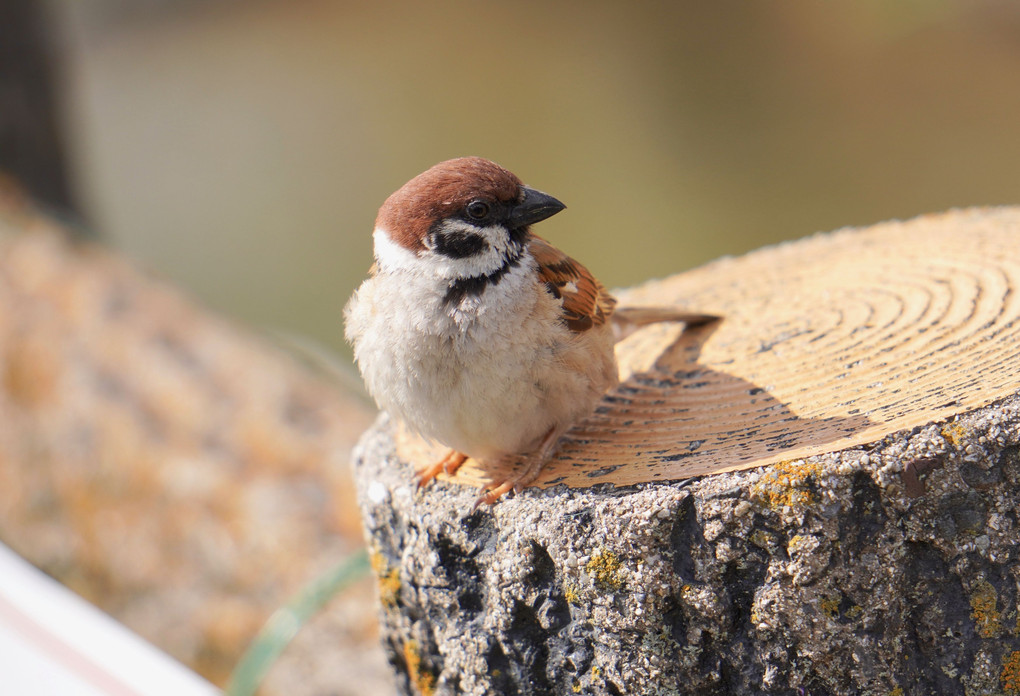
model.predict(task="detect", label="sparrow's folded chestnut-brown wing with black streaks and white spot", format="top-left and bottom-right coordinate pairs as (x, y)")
top-left (528, 237), bottom-right (616, 332)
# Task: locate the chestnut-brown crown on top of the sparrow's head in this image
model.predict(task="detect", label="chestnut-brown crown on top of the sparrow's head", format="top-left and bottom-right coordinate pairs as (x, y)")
top-left (375, 157), bottom-right (521, 251)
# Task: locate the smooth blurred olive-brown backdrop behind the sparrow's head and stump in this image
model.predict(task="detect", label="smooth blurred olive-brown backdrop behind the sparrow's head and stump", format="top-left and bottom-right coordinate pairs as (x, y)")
top-left (21, 0), bottom-right (1020, 352)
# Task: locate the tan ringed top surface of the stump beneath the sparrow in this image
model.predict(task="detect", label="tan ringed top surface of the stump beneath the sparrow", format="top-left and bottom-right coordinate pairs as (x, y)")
top-left (398, 208), bottom-right (1020, 487)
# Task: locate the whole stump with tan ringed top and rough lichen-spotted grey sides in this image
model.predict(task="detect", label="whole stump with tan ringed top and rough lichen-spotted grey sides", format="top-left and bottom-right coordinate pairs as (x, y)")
top-left (355, 208), bottom-right (1020, 696)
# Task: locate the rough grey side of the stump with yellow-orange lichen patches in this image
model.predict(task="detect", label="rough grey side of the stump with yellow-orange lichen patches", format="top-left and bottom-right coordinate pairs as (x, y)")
top-left (356, 398), bottom-right (1020, 696)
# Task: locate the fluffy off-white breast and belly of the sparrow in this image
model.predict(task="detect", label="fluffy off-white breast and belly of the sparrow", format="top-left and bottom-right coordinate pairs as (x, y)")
top-left (345, 231), bottom-right (615, 459)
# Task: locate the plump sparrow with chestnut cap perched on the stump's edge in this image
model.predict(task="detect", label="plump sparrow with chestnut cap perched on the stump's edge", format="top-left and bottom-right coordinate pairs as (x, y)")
top-left (344, 157), bottom-right (711, 507)
